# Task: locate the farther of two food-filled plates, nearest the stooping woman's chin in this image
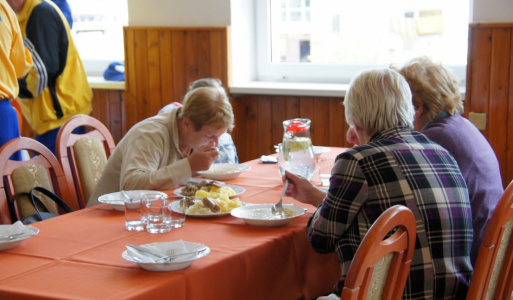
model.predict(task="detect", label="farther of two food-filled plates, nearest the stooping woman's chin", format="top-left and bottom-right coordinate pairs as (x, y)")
top-left (174, 181), bottom-right (246, 198)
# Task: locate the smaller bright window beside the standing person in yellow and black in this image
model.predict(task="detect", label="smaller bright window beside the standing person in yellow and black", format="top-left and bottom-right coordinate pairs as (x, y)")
top-left (68, 0), bottom-right (128, 76)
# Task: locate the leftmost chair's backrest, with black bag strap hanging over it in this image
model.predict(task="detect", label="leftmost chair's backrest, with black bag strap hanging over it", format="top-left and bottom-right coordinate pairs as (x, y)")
top-left (0, 137), bottom-right (72, 224)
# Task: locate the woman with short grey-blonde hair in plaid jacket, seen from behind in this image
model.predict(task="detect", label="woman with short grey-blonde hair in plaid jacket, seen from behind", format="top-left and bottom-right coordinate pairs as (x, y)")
top-left (285, 69), bottom-right (473, 299)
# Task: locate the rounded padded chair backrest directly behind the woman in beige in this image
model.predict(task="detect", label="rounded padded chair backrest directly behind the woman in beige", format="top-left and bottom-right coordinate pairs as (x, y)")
top-left (56, 115), bottom-right (116, 210)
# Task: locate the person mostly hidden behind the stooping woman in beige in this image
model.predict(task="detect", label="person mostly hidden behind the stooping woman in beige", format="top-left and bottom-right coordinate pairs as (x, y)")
top-left (159, 78), bottom-right (239, 164)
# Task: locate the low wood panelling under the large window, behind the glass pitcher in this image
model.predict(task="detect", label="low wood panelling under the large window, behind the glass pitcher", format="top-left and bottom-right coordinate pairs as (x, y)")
top-left (232, 95), bottom-right (350, 162)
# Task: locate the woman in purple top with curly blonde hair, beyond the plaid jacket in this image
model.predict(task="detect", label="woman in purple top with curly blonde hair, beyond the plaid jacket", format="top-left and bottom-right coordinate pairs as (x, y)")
top-left (398, 57), bottom-right (504, 265)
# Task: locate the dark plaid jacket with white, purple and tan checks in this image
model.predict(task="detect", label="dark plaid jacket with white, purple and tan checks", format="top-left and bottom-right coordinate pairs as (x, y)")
top-left (307, 127), bottom-right (473, 299)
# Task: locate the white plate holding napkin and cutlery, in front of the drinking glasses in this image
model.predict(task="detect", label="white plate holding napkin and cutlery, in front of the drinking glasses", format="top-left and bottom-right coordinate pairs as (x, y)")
top-left (121, 240), bottom-right (210, 272)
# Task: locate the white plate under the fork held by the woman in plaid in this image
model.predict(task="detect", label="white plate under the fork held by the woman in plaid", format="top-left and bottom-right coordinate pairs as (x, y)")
top-left (231, 204), bottom-right (305, 227)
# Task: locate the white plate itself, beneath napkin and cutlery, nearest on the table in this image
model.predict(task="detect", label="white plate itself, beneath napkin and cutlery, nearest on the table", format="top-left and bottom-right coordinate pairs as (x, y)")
top-left (121, 241), bottom-right (210, 272)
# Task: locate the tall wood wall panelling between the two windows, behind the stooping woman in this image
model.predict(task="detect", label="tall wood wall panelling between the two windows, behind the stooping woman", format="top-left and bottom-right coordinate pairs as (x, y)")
top-left (124, 27), bottom-right (229, 129)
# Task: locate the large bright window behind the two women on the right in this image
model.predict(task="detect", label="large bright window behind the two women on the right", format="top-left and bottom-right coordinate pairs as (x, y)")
top-left (256, 0), bottom-right (470, 83)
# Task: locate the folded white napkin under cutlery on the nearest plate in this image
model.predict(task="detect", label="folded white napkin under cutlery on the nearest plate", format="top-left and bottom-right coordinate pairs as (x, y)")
top-left (126, 240), bottom-right (190, 263)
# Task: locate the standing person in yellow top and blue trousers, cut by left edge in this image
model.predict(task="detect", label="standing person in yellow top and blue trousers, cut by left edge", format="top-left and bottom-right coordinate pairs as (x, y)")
top-left (0, 0), bottom-right (32, 160)
